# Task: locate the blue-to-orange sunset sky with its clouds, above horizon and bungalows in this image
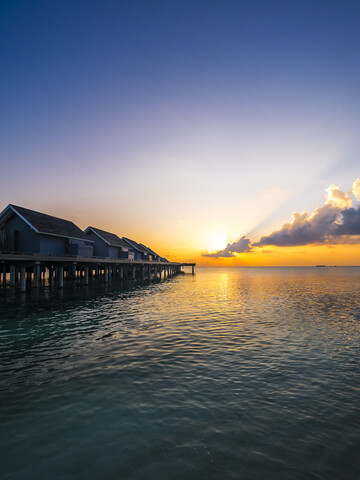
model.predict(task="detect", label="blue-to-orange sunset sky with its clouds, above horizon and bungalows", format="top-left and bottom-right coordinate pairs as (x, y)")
top-left (0, 0), bottom-right (360, 266)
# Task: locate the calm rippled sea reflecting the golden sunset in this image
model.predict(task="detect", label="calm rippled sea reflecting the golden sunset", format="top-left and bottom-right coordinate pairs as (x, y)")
top-left (0, 268), bottom-right (360, 480)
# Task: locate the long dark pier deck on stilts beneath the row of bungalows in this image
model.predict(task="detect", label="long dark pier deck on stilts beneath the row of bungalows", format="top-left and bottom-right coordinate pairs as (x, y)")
top-left (0, 252), bottom-right (196, 292)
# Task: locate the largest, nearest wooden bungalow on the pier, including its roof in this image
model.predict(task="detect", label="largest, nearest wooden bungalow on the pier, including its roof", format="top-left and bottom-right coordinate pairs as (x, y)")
top-left (0, 204), bottom-right (93, 257)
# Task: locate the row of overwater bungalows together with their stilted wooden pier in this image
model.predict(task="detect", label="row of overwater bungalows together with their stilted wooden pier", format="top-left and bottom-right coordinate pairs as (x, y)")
top-left (0, 204), bottom-right (195, 292)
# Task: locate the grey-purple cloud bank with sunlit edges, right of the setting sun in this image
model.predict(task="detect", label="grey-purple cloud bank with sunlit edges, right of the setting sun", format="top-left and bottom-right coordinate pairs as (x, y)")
top-left (202, 178), bottom-right (360, 258)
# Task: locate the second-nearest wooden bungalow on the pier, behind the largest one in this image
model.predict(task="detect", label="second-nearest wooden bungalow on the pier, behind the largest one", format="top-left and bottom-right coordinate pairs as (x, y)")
top-left (85, 227), bottom-right (135, 260)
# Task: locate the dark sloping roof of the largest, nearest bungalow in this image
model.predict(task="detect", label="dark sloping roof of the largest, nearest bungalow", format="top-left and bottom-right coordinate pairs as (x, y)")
top-left (8, 204), bottom-right (89, 240)
